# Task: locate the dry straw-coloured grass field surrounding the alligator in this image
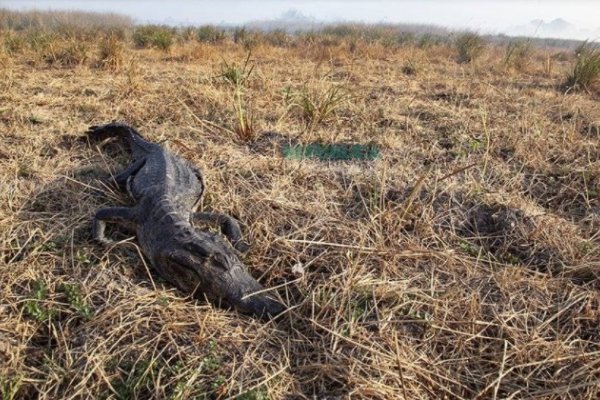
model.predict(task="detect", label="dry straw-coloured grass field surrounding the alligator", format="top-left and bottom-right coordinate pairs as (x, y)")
top-left (0, 9), bottom-right (600, 399)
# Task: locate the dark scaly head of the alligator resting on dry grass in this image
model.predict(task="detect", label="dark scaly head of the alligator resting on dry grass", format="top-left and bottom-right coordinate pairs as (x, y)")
top-left (157, 230), bottom-right (285, 318)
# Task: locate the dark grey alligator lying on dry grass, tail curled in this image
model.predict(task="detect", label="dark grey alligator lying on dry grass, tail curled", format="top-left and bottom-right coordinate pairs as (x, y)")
top-left (87, 122), bottom-right (285, 318)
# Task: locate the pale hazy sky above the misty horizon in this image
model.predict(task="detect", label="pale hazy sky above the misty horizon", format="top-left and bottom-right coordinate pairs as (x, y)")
top-left (0, 0), bottom-right (600, 40)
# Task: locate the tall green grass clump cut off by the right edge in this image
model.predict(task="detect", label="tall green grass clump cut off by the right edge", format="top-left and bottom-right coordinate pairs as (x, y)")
top-left (565, 41), bottom-right (600, 91)
